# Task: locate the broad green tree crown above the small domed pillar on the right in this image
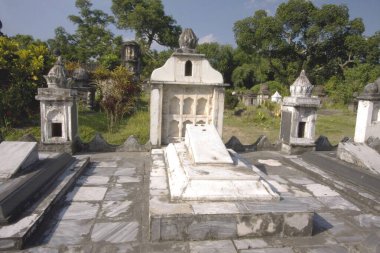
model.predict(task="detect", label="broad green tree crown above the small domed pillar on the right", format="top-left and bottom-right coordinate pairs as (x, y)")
top-left (234, 0), bottom-right (376, 84)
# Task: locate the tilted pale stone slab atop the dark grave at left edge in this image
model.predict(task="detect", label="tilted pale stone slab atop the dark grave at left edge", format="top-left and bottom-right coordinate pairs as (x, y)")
top-left (0, 141), bottom-right (38, 179)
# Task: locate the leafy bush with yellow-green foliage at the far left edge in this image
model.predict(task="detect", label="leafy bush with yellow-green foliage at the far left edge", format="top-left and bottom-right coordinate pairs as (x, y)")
top-left (0, 36), bottom-right (52, 127)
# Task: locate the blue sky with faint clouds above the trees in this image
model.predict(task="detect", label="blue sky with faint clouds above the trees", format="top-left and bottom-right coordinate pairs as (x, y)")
top-left (0, 0), bottom-right (380, 49)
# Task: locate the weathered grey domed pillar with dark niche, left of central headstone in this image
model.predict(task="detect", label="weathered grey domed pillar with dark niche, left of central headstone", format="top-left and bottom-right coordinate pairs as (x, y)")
top-left (36, 56), bottom-right (78, 153)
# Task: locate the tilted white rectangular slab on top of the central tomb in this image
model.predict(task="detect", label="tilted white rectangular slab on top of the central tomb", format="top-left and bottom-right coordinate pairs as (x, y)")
top-left (185, 124), bottom-right (233, 164)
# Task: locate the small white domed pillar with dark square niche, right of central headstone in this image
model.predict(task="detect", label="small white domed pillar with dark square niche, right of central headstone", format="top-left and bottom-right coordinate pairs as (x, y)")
top-left (280, 70), bottom-right (320, 154)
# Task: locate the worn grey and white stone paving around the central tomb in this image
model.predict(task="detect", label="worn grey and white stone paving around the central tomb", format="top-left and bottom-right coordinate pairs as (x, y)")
top-left (17, 151), bottom-right (380, 253)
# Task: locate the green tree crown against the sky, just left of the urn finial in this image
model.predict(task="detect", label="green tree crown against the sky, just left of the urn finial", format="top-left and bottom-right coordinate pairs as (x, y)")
top-left (112, 0), bottom-right (182, 49)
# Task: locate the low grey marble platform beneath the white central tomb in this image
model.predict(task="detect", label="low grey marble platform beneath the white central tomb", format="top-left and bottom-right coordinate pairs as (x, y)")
top-left (149, 149), bottom-right (314, 241)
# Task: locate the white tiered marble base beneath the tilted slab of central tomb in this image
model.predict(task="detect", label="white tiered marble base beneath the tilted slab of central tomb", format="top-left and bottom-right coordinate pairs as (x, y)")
top-left (165, 142), bottom-right (279, 201)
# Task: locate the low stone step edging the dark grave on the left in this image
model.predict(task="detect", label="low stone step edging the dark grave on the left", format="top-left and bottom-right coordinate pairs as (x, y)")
top-left (0, 154), bottom-right (89, 250)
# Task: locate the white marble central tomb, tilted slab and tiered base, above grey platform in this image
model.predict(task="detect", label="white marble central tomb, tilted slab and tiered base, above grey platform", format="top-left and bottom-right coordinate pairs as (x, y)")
top-left (165, 125), bottom-right (279, 201)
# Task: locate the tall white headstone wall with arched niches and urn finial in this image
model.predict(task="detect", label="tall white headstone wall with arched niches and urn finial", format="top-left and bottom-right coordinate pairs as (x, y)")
top-left (150, 29), bottom-right (228, 147)
